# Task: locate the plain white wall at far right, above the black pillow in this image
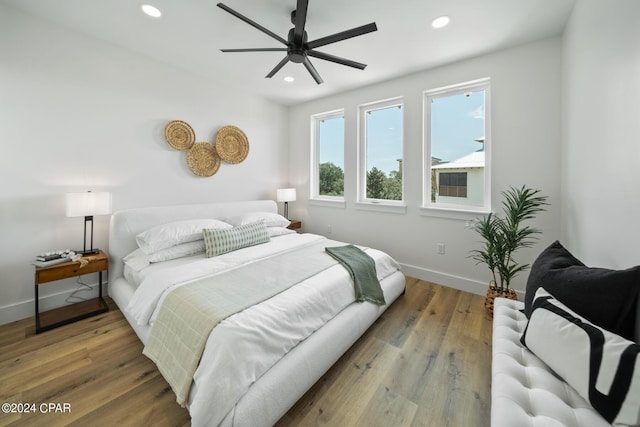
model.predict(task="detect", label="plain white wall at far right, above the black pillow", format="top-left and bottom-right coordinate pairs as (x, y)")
top-left (562, 0), bottom-right (640, 268)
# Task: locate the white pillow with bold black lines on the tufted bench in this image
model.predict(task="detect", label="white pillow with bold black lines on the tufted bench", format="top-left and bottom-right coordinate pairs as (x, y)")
top-left (521, 288), bottom-right (640, 426)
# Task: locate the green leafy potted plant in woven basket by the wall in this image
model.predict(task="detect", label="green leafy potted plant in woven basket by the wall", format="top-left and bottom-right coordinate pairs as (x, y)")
top-left (471, 186), bottom-right (547, 316)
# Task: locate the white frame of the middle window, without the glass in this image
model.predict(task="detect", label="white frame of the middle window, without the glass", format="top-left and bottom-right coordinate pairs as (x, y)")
top-left (356, 97), bottom-right (406, 213)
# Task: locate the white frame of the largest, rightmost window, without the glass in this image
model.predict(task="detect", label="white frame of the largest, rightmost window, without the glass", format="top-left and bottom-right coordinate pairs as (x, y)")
top-left (420, 77), bottom-right (492, 220)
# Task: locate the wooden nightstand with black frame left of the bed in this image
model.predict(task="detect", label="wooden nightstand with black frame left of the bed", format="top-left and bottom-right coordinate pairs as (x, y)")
top-left (35, 251), bottom-right (109, 333)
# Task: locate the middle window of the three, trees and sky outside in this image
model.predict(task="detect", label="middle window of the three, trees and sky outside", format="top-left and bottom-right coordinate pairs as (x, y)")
top-left (358, 98), bottom-right (403, 204)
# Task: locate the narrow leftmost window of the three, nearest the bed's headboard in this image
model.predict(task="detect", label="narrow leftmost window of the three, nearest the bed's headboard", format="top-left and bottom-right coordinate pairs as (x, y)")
top-left (311, 110), bottom-right (344, 201)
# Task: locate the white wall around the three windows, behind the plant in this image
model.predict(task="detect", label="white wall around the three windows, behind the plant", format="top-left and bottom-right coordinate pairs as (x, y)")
top-left (290, 38), bottom-right (561, 293)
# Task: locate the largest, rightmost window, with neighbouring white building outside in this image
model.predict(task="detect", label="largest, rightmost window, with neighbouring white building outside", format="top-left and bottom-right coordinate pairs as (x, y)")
top-left (423, 79), bottom-right (491, 212)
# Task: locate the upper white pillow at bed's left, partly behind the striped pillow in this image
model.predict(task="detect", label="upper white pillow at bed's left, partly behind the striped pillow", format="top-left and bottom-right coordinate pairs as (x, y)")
top-left (136, 219), bottom-right (231, 255)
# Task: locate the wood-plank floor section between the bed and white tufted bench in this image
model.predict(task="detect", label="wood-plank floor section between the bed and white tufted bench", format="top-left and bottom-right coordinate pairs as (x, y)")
top-left (277, 278), bottom-right (492, 427)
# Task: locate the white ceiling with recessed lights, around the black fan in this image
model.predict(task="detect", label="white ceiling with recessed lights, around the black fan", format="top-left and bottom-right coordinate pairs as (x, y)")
top-left (0, 0), bottom-right (575, 105)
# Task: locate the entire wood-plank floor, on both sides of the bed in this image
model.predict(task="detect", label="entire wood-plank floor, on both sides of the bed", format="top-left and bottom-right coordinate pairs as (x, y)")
top-left (0, 278), bottom-right (491, 427)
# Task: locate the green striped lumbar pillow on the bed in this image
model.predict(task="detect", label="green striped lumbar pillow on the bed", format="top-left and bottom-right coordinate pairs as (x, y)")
top-left (202, 220), bottom-right (269, 257)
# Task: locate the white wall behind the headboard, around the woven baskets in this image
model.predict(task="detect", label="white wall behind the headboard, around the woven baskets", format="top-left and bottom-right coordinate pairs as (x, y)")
top-left (0, 4), bottom-right (288, 324)
